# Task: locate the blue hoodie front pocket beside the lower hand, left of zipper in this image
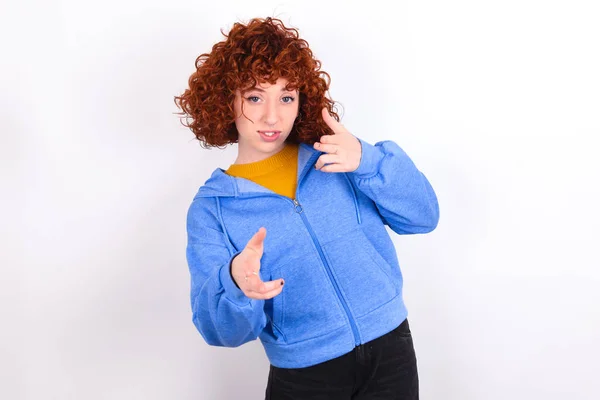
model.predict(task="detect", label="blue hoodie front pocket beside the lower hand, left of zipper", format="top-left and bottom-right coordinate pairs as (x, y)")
top-left (269, 253), bottom-right (346, 344)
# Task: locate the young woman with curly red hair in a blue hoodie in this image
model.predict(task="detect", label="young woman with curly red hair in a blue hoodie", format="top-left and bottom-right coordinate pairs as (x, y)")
top-left (175, 18), bottom-right (439, 400)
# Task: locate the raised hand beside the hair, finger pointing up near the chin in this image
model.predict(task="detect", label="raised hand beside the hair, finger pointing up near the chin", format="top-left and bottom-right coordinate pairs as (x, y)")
top-left (313, 108), bottom-right (362, 172)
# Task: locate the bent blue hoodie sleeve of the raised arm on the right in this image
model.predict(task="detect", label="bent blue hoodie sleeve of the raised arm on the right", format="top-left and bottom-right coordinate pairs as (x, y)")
top-left (349, 138), bottom-right (439, 234)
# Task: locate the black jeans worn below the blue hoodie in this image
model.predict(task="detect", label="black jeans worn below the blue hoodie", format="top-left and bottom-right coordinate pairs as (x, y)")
top-left (266, 320), bottom-right (419, 400)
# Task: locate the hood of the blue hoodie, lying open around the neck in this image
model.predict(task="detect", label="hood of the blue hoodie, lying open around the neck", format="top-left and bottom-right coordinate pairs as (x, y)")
top-left (195, 143), bottom-right (321, 197)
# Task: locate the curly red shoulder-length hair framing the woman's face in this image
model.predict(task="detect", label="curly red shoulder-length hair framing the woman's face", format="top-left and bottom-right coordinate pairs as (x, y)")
top-left (174, 17), bottom-right (340, 148)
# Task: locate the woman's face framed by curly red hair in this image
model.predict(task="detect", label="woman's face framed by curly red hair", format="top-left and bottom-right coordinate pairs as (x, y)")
top-left (233, 78), bottom-right (299, 164)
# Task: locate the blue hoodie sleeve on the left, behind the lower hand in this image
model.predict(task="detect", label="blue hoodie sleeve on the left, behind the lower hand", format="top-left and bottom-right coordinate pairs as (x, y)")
top-left (186, 198), bottom-right (266, 347)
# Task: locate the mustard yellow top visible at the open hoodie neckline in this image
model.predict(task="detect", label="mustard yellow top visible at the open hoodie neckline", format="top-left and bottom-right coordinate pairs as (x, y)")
top-left (225, 143), bottom-right (299, 199)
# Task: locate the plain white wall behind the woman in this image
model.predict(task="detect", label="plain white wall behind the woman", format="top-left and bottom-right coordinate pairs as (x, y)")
top-left (0, 0), bottom-right (600, 400)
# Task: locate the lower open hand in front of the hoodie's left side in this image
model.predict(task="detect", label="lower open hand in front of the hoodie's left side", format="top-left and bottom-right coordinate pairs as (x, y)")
top-left (231, 227), bottom-right (283, 300)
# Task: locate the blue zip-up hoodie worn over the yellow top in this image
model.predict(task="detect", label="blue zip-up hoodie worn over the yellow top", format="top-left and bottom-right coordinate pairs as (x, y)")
top-left (186, 138), bottom-right (439, 368)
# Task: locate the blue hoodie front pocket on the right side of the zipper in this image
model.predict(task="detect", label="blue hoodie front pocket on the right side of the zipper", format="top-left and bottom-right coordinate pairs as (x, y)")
top-left (323, 226), bottom-right (400, 318)
